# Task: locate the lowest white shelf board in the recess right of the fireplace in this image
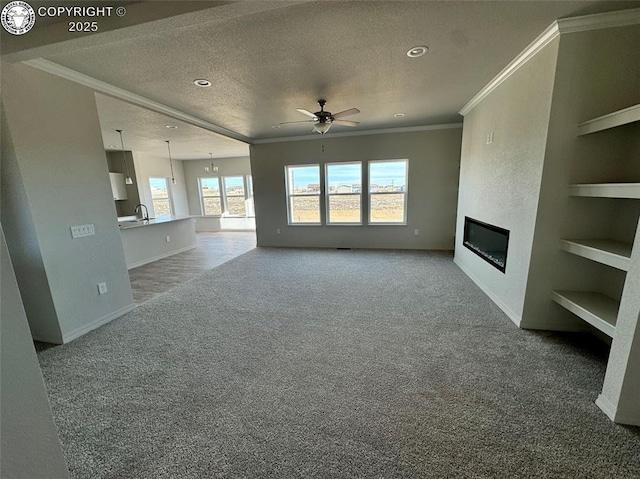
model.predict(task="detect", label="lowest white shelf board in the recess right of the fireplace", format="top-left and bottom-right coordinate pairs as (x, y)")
top-left (551, 291), bottom-right (620, 338)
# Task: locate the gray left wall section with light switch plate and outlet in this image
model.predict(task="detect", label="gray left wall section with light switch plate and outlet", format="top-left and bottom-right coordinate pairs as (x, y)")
top-left (2, 63), bottom-right (134, 342)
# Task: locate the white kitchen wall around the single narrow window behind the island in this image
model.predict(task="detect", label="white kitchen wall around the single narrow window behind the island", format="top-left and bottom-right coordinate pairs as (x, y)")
top-left (129, 151), bottom-right (189, 218)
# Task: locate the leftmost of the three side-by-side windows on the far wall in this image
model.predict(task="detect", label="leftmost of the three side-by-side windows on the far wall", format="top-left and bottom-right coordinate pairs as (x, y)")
top-left (285, 165), bottom-right (321, 224)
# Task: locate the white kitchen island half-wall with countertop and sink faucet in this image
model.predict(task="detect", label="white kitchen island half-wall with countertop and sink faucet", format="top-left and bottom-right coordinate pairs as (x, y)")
top-left (118, 216), bottom-right (197, 269)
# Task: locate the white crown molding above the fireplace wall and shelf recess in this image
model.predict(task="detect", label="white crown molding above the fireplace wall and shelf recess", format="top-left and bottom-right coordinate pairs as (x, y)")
top-left (459, 8), bottom-right (640, 116)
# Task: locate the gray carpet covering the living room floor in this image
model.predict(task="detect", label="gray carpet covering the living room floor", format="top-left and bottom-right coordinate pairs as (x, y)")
top-left (38, 248), bottom-right (640, 479)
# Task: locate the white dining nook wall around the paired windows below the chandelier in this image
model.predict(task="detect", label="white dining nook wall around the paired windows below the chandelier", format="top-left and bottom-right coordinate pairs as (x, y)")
top-left (183, 156), bottom-right (256, 231)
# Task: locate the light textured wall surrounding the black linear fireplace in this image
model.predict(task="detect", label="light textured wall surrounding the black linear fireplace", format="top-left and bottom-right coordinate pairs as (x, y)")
top-left (454, 38), bottom-right (559, 325)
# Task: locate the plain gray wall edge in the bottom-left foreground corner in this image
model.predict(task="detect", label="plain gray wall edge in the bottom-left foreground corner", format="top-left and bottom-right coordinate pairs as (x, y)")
top-left (0, 229), bottom-right (69, 479)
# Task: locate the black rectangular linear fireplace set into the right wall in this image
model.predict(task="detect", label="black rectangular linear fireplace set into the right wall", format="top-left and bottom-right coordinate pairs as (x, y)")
top-left (462, 216), bottom-right (509, 273)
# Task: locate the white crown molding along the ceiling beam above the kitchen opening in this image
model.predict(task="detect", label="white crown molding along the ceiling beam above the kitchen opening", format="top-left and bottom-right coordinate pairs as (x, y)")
top-left (23, 58), bottom-right (252, 144)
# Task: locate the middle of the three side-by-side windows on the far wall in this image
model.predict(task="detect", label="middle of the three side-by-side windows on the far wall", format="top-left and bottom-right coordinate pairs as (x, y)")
top-left (326, 162), bottom-right (362, 224)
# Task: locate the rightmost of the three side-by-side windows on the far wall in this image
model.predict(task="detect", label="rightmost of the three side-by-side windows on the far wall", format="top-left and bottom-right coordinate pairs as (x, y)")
top-left (369, 160), bottom-right (408, 224)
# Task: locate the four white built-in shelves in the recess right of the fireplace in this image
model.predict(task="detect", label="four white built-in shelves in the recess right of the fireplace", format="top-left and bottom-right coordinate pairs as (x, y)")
top-left (551, 104), bottom-right (640, 338)
